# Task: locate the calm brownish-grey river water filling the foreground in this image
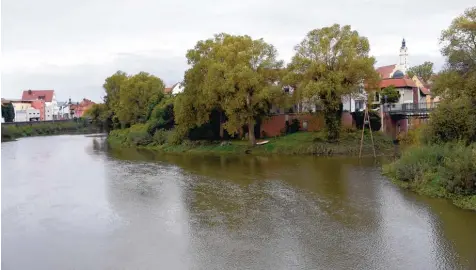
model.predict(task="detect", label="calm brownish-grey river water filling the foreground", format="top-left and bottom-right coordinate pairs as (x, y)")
top-left (1, 135), bottom-right (476, 270)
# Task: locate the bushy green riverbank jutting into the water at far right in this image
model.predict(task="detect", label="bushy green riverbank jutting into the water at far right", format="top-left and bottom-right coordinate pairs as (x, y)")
top-left (383, 143), bottom-right (476, 210)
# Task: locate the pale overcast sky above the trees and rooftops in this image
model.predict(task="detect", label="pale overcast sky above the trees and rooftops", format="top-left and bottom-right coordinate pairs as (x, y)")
top-left (1, 0), bottom-right (474, 101)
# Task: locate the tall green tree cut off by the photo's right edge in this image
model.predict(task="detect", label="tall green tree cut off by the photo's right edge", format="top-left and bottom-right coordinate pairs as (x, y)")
top-left (428, 7), bottom-right (476, 143)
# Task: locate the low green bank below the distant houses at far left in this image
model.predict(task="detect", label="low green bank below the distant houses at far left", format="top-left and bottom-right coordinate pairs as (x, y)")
top-left (2, 119), bottom-right (101, 142)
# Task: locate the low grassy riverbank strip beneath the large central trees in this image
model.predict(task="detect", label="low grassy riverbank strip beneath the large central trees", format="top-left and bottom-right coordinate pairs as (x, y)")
top-left (108, 130), bottom-right (395, 156)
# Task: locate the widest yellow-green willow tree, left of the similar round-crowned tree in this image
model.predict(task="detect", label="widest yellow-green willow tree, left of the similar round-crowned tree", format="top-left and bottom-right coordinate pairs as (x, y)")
top-left (174, 34), bottom-right (283, 145)
